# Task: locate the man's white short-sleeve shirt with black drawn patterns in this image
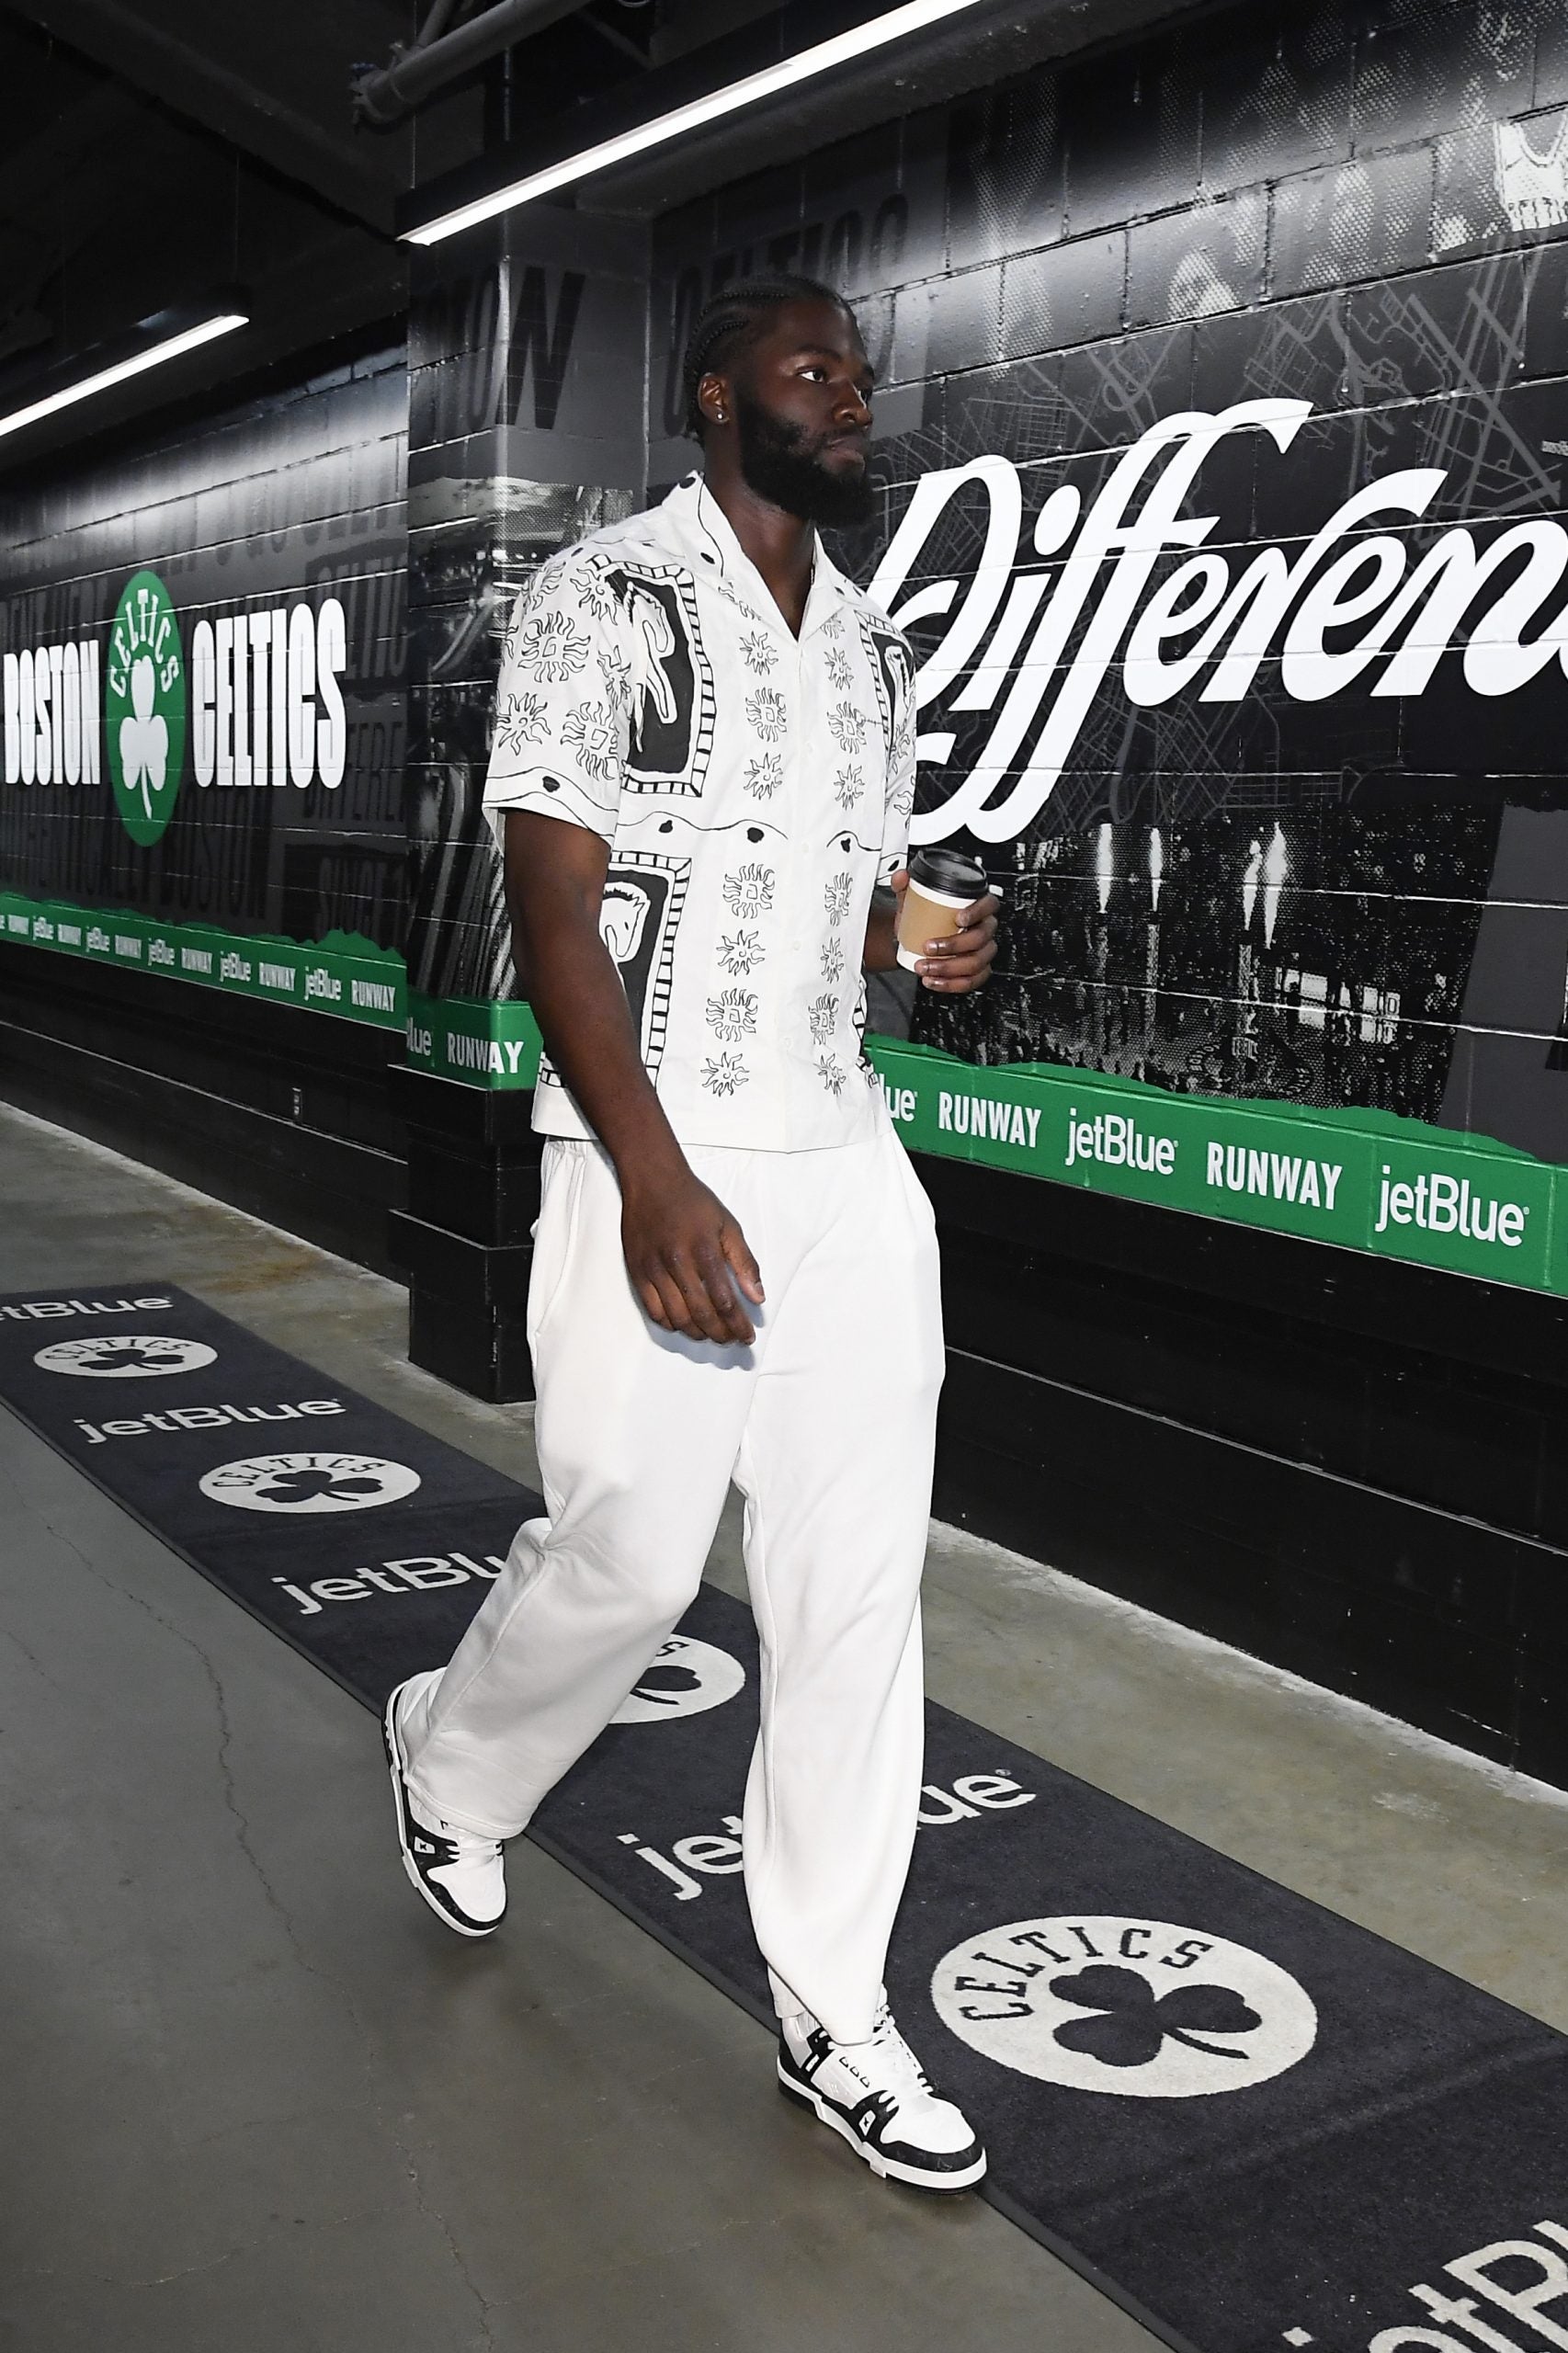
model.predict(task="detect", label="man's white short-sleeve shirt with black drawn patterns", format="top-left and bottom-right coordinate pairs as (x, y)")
top-left (485, 478), bottom-right (914, 1151)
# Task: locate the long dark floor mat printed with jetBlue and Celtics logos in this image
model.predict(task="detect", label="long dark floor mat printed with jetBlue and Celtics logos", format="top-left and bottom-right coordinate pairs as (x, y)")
top-left (0, 1282), bottom-right (1568, 2353)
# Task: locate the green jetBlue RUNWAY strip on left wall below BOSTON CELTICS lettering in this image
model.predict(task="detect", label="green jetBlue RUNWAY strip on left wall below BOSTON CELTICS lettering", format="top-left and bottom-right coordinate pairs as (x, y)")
top-left (0, 890), bottom-right (407, 1029)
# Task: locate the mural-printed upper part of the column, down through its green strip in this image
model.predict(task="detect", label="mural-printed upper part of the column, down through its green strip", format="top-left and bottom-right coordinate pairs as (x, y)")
top-left (407, 207), bottom-right (649, 1030)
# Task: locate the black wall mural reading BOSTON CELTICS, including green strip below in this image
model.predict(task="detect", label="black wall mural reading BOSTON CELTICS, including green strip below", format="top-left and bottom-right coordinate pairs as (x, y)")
top-left (0, 350), bottom-right (405, 1029)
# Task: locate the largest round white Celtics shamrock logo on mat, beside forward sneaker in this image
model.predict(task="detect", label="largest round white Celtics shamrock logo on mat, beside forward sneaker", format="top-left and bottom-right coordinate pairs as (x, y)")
top-left (930, 1913), bottom-right (1318, 2099)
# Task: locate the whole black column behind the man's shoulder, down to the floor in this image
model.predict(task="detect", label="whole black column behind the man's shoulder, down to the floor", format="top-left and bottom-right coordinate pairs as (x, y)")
top-left (391, 207), bottom-right (647, 1398)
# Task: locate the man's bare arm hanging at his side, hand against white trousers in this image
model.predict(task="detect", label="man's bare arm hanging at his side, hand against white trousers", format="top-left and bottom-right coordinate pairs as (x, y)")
top-left (506, 810), bottom-right (763, 1344)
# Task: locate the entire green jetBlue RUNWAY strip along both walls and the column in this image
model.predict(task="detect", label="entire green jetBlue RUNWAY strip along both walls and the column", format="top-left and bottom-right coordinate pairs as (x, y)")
top-left (0, 892), bottom-right (1568, 1297)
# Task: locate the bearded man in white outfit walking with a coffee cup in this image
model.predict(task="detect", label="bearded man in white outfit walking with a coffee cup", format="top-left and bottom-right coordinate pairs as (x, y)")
top-left (386, 278), bottom-right (996, 2188)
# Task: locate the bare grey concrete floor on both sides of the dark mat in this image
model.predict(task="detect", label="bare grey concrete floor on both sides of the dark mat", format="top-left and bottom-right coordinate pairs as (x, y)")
top-left (0, 1108), bottom-right (1568, 2353)
